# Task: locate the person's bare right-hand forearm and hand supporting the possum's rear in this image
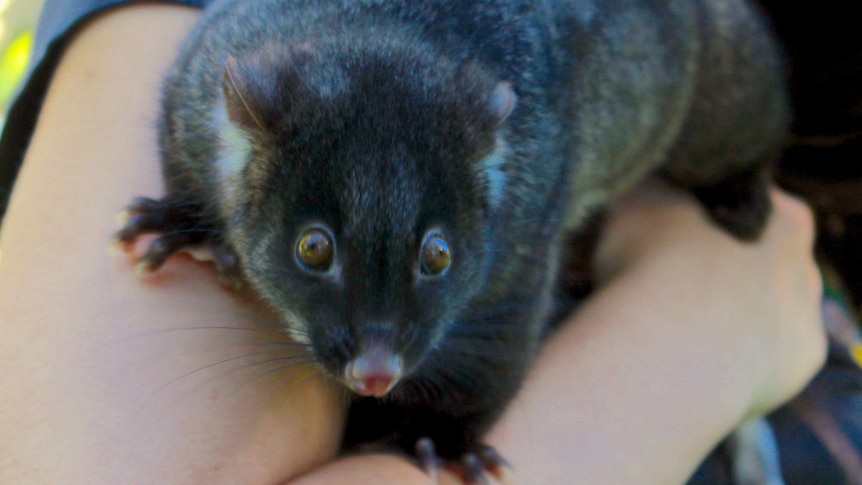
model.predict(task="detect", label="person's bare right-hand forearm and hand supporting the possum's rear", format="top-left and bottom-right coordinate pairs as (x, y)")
top-left (489, 182), bottom-right (825, 484)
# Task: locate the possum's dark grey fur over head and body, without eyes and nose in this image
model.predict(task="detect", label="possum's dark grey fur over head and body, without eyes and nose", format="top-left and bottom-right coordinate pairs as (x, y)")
top-left (120, 0), bottom-right (787, 474)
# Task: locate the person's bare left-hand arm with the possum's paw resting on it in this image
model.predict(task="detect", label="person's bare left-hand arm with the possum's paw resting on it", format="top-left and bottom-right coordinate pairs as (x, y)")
top-left (0, 4), bottom-right (340, 484)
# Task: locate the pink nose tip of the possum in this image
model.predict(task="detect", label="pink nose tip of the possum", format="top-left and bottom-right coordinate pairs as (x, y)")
top-left (344, 348), bottom-right (402, 397)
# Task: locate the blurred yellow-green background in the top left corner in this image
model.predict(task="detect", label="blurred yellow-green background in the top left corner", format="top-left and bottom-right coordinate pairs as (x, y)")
top-left (0, 0), bottom-right (42, 126)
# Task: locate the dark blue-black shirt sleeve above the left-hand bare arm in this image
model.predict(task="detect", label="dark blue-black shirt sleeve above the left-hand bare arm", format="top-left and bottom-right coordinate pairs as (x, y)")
top-left (0, 0), bottom-right (211, 221)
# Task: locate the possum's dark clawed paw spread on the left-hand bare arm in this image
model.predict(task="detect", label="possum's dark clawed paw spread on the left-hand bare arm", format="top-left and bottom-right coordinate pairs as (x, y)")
top-left (115, 197), bottom-right (243, 288)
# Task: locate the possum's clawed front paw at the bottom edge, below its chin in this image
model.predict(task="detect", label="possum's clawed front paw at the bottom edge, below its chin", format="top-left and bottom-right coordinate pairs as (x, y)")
top-left (416, 438), bottom-right (511, 485)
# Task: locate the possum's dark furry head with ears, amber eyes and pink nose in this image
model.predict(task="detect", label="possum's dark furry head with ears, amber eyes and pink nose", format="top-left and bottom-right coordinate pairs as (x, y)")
top-left (216, 43), bottom-right (516, 397)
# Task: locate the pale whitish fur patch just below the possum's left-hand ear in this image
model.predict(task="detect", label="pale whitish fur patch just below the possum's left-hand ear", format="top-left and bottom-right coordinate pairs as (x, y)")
top-left (213, 103), bottom-right (251, 198)
